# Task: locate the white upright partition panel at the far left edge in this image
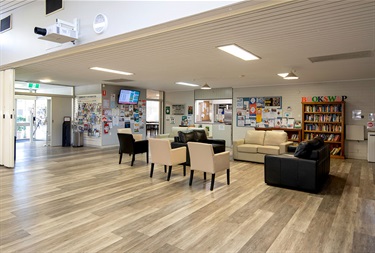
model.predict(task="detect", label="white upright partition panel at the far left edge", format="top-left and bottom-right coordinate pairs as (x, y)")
top-left (0, 69), bottom-right (15, 168)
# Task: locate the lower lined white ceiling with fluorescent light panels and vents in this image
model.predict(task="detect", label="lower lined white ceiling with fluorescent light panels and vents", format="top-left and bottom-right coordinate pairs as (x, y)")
top-left (3, 0), bottom-right (375, 91)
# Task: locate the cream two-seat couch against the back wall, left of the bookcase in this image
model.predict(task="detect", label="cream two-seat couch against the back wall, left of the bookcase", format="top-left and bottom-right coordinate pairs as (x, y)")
top-left (233, 130), bottom-right (293, 163)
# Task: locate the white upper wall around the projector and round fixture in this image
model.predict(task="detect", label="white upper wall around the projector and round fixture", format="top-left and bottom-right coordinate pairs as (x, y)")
top-left (0, 1), bottom-right (238, 65)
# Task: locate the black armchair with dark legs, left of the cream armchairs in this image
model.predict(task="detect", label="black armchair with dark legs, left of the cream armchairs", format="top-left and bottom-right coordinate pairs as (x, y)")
top-left (117, 133), bottom-right (148, 166)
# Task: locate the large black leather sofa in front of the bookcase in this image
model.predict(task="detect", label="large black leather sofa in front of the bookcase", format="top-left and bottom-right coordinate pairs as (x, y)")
top-left (264, 144), bottom-right (330, 192)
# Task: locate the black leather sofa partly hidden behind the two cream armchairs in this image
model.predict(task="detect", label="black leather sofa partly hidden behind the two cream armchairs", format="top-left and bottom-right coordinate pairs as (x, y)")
top-left (171, 129), bottom-right (225, 166)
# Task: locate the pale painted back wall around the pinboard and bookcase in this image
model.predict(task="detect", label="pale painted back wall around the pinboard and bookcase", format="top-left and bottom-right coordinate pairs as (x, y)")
top-left (233, 80), bottom-right (375, 159)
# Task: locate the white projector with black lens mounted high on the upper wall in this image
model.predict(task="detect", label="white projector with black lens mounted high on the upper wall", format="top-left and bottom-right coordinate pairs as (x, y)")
top-left (34, 19), bottom-right (78, 43)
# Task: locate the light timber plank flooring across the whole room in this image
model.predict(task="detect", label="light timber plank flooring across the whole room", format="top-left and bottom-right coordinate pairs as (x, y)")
top-left (0, 142), bottom-right (375, 253)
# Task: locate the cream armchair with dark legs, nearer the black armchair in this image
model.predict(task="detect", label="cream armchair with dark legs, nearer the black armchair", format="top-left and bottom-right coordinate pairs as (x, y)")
top-left (149, 138), bottom-right (186, 181)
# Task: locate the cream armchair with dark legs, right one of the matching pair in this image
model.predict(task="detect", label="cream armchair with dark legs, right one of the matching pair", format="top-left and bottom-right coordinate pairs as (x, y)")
top-left (187, 142), bottom-right (230, 191)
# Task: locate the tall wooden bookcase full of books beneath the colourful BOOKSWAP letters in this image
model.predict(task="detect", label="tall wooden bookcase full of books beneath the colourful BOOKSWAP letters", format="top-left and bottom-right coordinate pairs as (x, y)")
top-left (302, 102), bottom-right (345, 158)
